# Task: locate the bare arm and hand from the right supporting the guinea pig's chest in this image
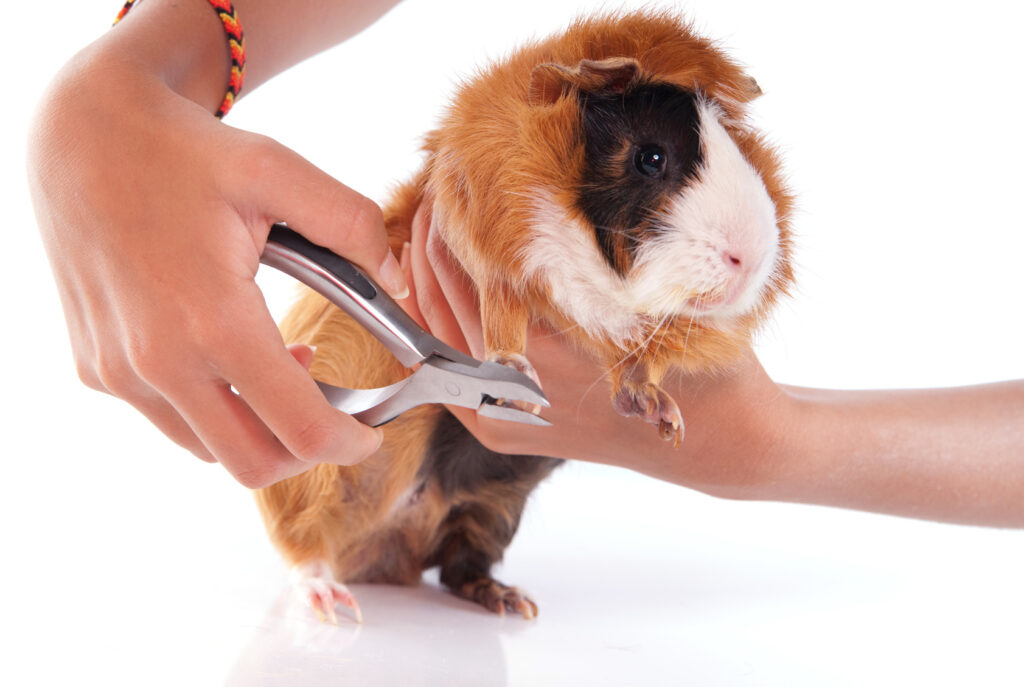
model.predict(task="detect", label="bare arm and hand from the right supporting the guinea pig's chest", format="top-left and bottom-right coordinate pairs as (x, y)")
top-left (403, 201), bottom-right (1024, 527)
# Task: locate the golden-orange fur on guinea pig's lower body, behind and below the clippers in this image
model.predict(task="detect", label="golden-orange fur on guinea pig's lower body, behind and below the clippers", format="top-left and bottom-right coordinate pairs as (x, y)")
top-left (257, 284), bottom-right (444, 583)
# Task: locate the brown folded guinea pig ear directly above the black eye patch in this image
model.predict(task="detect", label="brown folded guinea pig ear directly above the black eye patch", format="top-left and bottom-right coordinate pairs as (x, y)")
top-left (529, 57), bottom-right (640, 105)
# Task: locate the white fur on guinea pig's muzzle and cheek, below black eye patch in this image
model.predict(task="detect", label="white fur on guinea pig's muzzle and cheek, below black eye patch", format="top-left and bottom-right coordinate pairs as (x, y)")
top-left (523, 102), bottom-right (778, 341)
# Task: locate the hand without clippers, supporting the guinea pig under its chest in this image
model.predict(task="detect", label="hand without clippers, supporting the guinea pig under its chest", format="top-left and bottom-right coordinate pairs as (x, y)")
top-left (403, 201), bottom-right (791, 498)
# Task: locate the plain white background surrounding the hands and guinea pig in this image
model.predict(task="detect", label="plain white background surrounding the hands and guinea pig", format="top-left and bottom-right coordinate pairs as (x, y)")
top-left (0, 0), bottom-right (1024, 685)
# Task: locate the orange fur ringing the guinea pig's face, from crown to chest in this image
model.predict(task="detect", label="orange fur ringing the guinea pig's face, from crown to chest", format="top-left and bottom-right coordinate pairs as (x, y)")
top-left (426, 11), bottom-right (793, 370)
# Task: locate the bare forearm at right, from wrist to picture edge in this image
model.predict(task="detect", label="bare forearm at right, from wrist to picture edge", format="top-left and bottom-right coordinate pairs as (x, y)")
top-left (775, 381), bottom-right (1024, 527)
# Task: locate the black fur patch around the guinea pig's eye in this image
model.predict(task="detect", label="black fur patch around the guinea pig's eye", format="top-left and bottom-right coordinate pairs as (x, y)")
top-left (578, 84), bottom-right (702, 273)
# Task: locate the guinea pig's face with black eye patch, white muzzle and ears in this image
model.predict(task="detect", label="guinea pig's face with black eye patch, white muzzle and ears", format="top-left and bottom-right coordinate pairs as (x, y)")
top-left (520, 57), bottom-right (791, 350)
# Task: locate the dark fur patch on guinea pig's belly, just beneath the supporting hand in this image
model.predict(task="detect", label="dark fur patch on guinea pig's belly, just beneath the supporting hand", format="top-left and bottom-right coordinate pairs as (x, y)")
top-left (418, 411), bottom-right (562, 499)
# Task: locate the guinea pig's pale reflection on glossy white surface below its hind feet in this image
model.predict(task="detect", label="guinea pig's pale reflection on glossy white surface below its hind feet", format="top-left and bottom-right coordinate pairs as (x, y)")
top-left (225, 584), bottom-right (526, 687)
